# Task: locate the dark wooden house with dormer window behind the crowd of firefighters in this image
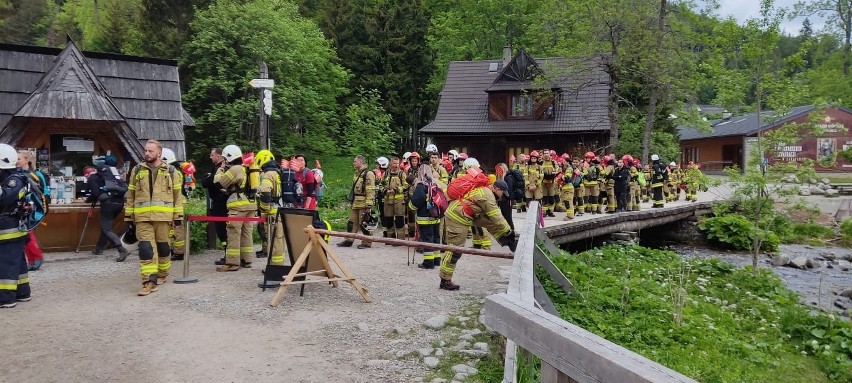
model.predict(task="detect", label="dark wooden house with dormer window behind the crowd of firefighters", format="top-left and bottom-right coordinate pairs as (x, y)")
top-left (420, 48), bottom-right (612, 167)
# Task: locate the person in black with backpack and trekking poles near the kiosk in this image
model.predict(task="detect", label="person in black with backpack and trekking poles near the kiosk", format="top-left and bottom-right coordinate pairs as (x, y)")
top-left (86, 155), bottom-right (130, 262)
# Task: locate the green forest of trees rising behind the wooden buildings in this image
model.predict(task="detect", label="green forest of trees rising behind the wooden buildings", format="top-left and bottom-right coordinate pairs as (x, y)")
top-left (0, 0), bottom-right (852, 162)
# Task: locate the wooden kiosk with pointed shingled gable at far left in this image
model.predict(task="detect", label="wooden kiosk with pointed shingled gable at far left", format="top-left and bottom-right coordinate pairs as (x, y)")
top-left (0, 40), bottom-right (195, 252)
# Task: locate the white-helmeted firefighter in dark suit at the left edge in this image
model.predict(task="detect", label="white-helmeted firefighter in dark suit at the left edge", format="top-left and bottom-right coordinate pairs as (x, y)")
top-left (0, 144), bottom-right (30, 308)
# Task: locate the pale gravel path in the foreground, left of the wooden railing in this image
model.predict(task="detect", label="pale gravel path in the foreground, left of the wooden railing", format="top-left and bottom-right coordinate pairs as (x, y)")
top-left (0, 239), bottom-right (511, 382)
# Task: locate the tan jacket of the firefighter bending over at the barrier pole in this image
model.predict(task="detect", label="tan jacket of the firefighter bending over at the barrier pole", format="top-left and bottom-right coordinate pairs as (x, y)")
top-left (444, 186), bottom-right (511, 239)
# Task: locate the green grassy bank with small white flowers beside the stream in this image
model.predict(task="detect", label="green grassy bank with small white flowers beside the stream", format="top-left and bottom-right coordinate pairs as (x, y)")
top-left (538, 246), bottom-right (852, 383)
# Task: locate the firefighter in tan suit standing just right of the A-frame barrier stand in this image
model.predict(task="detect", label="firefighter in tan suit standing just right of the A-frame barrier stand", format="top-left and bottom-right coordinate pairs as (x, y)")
top-left (337, 156), bottom-right (376, 249)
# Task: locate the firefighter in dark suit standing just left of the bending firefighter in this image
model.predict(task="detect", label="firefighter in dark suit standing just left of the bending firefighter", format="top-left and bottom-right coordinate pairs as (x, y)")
top-left (408, 166), bottom-right (441, 269)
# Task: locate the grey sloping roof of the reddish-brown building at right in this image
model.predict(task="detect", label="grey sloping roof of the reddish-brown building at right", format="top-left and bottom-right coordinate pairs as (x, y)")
top-left (677, 105), bottom-right (816, 140)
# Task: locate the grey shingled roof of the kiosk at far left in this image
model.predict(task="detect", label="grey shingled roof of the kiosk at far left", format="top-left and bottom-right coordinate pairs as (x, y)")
top-left (0, 41), bottom-right (194, 158)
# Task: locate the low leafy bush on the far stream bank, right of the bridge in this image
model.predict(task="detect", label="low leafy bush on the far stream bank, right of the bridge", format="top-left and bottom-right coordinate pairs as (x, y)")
top-left (698, 214), bottom-right (781, 251)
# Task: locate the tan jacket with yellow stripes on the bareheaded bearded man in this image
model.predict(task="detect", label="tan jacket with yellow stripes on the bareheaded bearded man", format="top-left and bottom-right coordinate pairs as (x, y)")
top-left (124, 162), bottom-right (183, 222)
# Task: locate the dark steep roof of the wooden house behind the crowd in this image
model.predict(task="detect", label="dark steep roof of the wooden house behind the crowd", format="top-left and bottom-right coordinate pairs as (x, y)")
top-left (420, 50), bottom-right (611, 135)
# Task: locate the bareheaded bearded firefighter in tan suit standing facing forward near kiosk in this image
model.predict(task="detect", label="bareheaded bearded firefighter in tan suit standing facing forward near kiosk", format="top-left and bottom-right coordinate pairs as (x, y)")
top-left (124, 140), bottom-right (183, 296)
